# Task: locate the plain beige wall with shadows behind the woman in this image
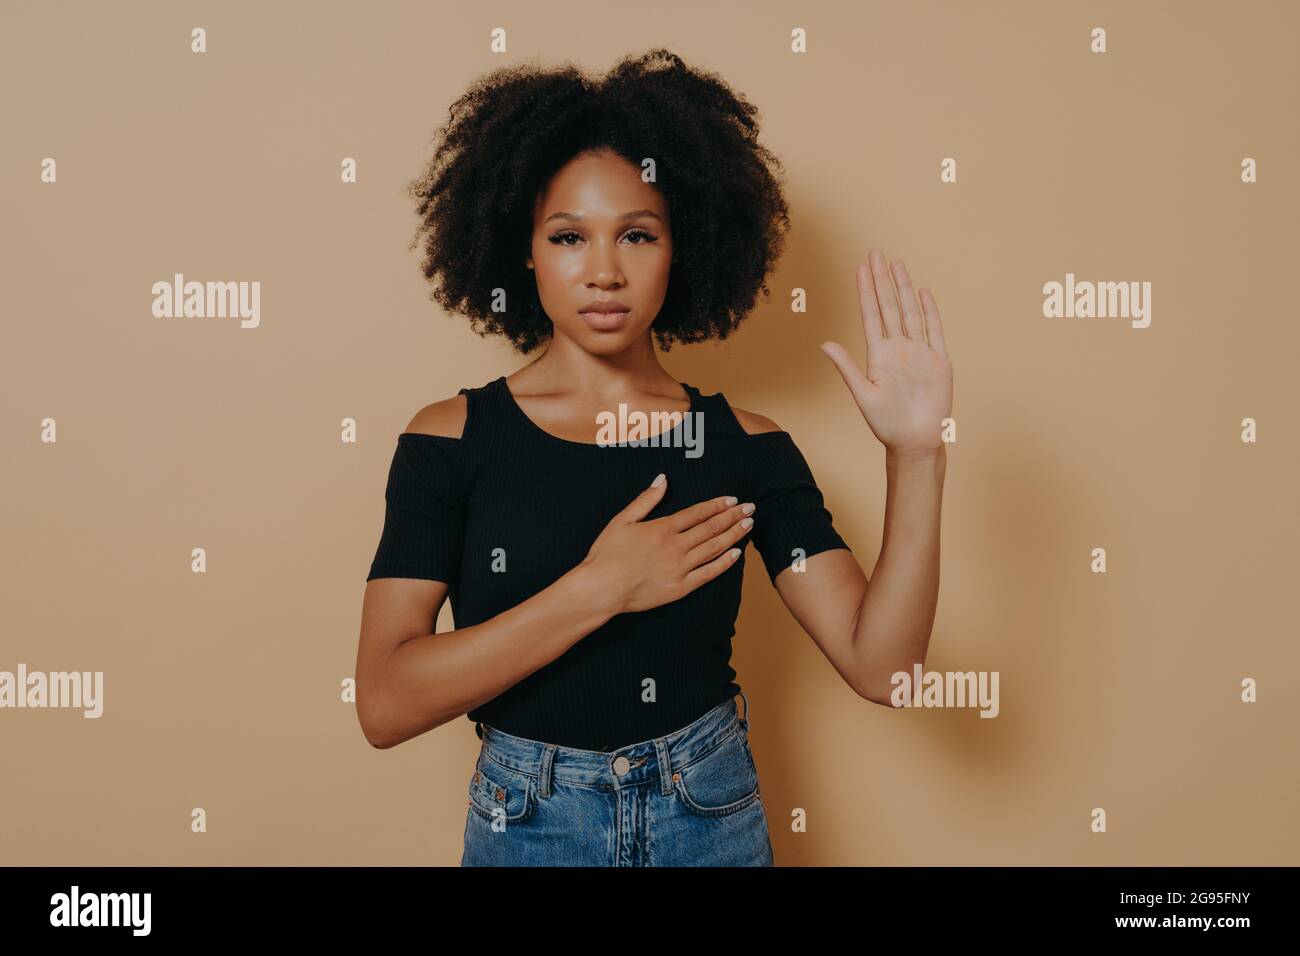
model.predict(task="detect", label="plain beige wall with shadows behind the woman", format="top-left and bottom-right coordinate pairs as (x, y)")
top-left (0, 1), bottom-right (1300, 865)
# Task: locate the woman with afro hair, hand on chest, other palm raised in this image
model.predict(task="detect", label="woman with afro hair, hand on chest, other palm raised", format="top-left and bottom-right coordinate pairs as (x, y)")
top-left (356, 49), bottom-right (952, 866)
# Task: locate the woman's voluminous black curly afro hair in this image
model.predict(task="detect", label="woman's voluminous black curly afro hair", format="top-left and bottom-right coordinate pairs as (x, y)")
top-left (408, 49), bottom-right (789, 352)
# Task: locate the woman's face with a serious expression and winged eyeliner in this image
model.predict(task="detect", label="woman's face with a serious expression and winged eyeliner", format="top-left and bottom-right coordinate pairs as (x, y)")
top-left (527, 151), bottom-right (673, 354)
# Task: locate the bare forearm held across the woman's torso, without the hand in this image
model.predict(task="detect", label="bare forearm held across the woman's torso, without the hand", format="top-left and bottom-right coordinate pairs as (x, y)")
top-left (376, 563), bottom-right (618, 747)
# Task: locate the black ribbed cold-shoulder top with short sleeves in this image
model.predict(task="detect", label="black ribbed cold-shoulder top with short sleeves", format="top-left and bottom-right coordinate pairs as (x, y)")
top-left (367, 376), bottom-right (849, 750)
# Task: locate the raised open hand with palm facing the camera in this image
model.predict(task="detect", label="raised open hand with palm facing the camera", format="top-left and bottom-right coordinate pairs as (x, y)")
top-left (822, 250), bottom-right (953, 455)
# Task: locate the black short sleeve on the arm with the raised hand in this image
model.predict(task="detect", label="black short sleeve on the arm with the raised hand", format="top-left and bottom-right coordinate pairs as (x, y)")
top-left (749, 432), bottom-right (853, 584)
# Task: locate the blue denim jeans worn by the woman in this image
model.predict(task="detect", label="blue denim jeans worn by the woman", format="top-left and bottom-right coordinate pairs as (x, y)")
top-left (460, 693), bottom-right (772, 866)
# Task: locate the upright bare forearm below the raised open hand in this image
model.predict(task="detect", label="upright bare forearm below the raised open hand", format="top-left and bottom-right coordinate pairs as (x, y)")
top-left (853, 447), bottom-right (948, 702)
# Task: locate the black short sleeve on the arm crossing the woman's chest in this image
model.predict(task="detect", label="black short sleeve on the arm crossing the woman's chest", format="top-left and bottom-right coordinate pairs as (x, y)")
top-left (365, 432), bottom-right (468, 585)
